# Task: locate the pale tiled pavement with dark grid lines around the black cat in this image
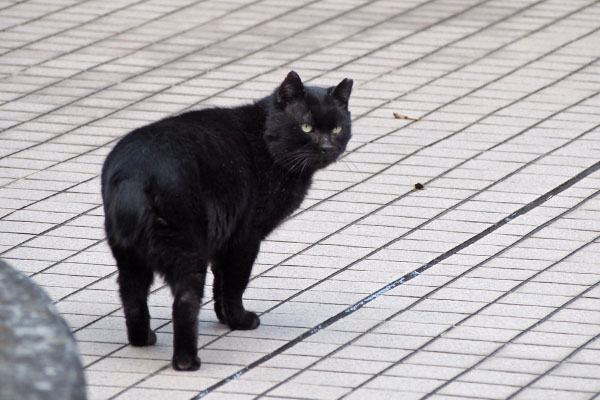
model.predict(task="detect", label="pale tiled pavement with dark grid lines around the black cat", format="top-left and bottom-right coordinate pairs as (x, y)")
top-left (0, 0), bottom-right (600, 400)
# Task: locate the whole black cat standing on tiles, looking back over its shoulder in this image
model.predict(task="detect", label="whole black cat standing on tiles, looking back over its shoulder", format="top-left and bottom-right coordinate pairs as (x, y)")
top-left (102, 71), bottom-right (352, 370)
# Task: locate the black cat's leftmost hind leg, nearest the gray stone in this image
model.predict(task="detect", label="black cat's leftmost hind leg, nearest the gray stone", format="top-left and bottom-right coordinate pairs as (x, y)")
top-left (113, 249), bottom-right (156, 346)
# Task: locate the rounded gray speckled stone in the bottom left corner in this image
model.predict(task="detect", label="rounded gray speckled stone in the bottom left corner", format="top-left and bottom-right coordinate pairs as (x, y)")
top-left (0, 260), bottom-right (86, 400)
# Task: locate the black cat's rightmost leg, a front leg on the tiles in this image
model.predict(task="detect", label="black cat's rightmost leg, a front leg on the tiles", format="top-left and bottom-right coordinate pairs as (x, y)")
top-left (212, 241), bottom-right (260, 330)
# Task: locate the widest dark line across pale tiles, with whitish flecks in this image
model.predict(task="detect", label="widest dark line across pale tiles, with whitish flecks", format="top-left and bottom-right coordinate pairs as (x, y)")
top-left (192, 162), bottom-right (600, 400)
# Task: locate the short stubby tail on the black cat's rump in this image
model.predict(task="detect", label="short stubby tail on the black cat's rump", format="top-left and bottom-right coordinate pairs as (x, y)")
top-left (103, 179), bottom-right (150, 249)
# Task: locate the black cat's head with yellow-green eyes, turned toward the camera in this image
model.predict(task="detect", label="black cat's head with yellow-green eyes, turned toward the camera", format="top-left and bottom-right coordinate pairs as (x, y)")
top-left (265, 71), bottom-right (353, 173)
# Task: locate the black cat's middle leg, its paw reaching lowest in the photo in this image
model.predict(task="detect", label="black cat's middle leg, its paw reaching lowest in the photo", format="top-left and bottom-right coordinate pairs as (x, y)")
top-left (172, 267), bottom-right (206, 371)
